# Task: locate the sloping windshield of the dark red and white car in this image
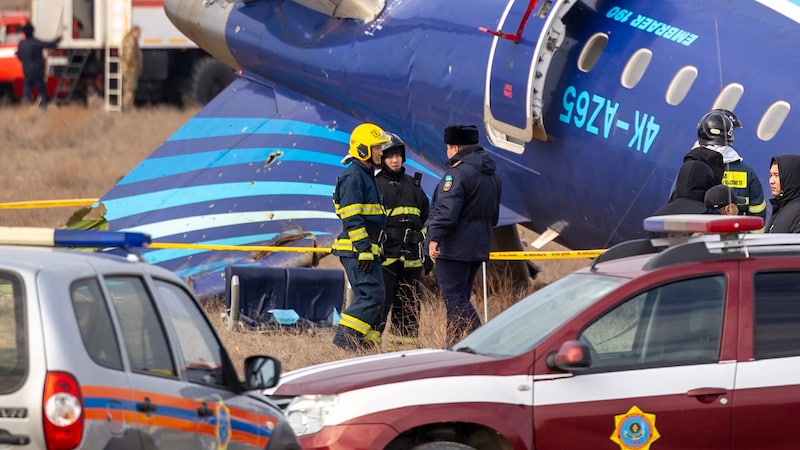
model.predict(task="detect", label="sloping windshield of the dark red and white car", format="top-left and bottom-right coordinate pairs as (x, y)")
top-left (453, 274), bottom-right (628, 357)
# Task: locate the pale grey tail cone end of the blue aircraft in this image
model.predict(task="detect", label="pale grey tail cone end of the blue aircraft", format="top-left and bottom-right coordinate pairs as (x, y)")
top-left (164, 0), bottom-right (239, 69)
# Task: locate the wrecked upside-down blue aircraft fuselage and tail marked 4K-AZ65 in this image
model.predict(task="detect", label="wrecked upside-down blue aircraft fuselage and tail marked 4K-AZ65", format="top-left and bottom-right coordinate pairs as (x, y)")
top-left (89, 0), bottom-right (800, 294)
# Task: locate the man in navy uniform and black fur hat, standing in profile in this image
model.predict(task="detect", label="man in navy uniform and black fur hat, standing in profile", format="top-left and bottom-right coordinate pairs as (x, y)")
top-left (427, 125), bottom-right (501, 346)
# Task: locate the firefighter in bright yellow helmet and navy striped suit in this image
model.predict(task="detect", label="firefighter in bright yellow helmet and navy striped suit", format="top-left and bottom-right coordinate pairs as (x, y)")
top-left (332, 123), bottom-right (390, 351)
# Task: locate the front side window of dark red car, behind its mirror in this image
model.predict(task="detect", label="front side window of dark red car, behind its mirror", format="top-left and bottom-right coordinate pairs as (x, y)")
top-left (579, 275), bottom-right (725, 370)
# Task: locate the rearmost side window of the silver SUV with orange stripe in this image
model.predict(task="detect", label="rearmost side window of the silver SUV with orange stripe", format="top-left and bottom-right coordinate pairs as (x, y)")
top-left (70, 278), bottom-right (122, 369)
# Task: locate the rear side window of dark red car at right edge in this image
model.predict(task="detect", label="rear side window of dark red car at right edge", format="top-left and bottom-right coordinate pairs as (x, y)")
top-left (753, 272), bottom-right (800, 359)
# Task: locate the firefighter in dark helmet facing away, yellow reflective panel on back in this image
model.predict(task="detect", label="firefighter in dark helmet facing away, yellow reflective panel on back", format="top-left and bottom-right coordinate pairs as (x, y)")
top-left (697, 109), bottom-right (767, 219)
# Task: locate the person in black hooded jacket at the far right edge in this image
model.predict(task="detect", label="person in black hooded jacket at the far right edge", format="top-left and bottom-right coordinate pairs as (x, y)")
top-left (767, 155), bottom-right (800, 233)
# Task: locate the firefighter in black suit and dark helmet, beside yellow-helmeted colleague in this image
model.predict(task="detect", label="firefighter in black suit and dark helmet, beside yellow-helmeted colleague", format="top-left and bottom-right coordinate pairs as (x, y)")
top-left (377, 133), bottom-right (429, 346)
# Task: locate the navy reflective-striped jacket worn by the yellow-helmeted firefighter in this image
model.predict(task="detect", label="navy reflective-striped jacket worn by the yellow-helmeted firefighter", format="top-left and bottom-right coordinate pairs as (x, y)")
top-left (332, 160), bottom-right (386, 260)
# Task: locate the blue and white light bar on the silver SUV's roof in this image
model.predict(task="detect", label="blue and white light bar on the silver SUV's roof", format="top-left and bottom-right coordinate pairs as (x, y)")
top-left (0, 227), bottom-right (151, 248)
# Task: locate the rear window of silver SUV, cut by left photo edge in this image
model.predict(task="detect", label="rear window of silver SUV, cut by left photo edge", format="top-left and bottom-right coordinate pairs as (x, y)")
top-left (0, 274), bottom-right (28, 394)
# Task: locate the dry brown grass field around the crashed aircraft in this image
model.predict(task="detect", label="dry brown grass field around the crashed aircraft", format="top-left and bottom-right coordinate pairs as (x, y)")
top-left (0, 101), bottom-right (586, 370)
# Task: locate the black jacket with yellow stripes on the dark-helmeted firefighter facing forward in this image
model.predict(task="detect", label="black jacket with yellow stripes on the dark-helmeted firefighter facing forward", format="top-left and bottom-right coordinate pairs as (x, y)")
top-left (376, 167), bottom-right (429, 269)
